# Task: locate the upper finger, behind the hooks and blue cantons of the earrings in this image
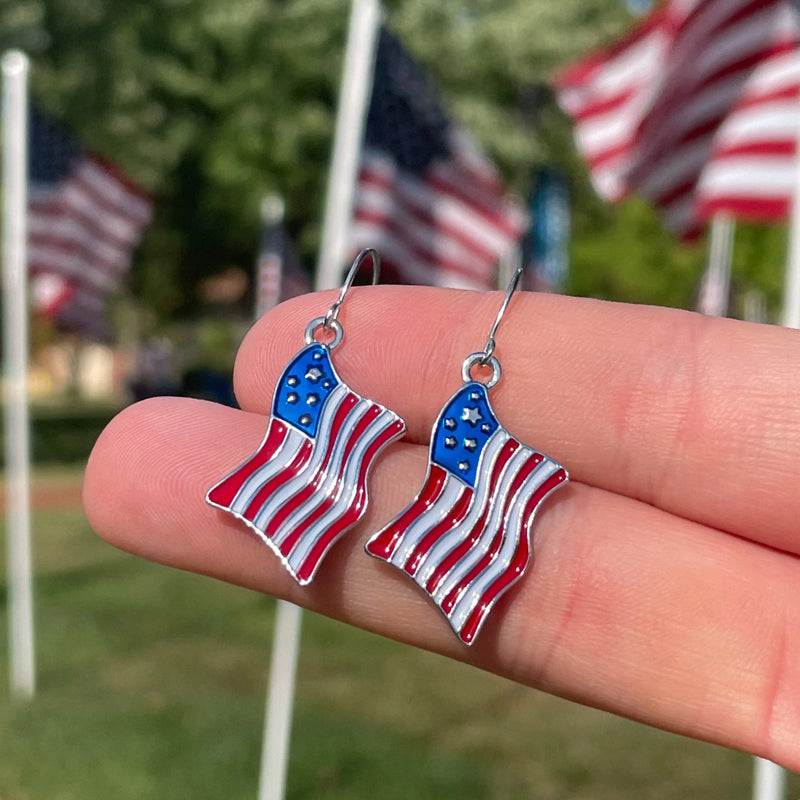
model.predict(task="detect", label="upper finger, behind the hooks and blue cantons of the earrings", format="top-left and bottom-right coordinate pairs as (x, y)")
top-left (235, 286), bottom-right (800, 552)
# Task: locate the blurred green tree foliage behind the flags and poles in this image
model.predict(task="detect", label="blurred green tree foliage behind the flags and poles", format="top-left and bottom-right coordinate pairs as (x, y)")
top-left (0, 0), bottom-right (782, 328)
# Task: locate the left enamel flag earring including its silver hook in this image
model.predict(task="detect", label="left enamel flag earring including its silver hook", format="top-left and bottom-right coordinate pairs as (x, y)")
top-left (206, 249), bottom-right (406, 585)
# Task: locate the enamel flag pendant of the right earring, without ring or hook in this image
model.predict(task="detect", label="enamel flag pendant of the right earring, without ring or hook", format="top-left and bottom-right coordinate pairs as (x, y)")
top-left (367, 382), bottom-right (567, 644)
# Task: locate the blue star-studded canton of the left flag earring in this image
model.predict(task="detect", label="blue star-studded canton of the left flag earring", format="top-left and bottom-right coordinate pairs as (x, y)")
top-left (272, 344), bottom-right (339, 438)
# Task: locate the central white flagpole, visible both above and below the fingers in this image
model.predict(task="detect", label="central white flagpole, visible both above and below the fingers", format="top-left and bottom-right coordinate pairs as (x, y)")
top-left (258, 0), bottom-right (381, 800)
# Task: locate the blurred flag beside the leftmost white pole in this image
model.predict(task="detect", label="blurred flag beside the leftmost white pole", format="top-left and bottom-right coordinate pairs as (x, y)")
top-left (28, 109), bottom-right (152, 338)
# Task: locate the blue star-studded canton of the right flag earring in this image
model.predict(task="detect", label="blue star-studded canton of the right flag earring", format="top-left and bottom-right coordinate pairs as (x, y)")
top-left (431, 381), bottom-right (500, 489)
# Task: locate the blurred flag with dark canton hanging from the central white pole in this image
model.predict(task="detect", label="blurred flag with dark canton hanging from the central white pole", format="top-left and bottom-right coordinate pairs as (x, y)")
top-left (349, 29), bottom-right (525, 289)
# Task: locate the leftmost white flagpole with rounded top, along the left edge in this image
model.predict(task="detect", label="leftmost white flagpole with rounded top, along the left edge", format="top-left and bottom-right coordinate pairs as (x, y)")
top-left (2, 50), bottom-right (36, 698)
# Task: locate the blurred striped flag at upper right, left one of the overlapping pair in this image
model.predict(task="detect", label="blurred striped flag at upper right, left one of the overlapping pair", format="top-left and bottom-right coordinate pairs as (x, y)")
top-left (557, 0), bottom-right (797, 237)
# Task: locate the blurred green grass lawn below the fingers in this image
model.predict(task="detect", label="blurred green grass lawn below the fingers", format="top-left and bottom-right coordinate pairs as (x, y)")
top-left (0, 478), bottom-right (800, 800)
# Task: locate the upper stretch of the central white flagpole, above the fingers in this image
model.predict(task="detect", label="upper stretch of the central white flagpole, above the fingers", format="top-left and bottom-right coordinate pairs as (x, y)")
top-left (314, 0), bottom-right (381, 291)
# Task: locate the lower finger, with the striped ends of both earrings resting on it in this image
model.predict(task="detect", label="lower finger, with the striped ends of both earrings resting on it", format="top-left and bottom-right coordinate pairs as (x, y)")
top-left (85, 398), bottom-right (800, 769)
